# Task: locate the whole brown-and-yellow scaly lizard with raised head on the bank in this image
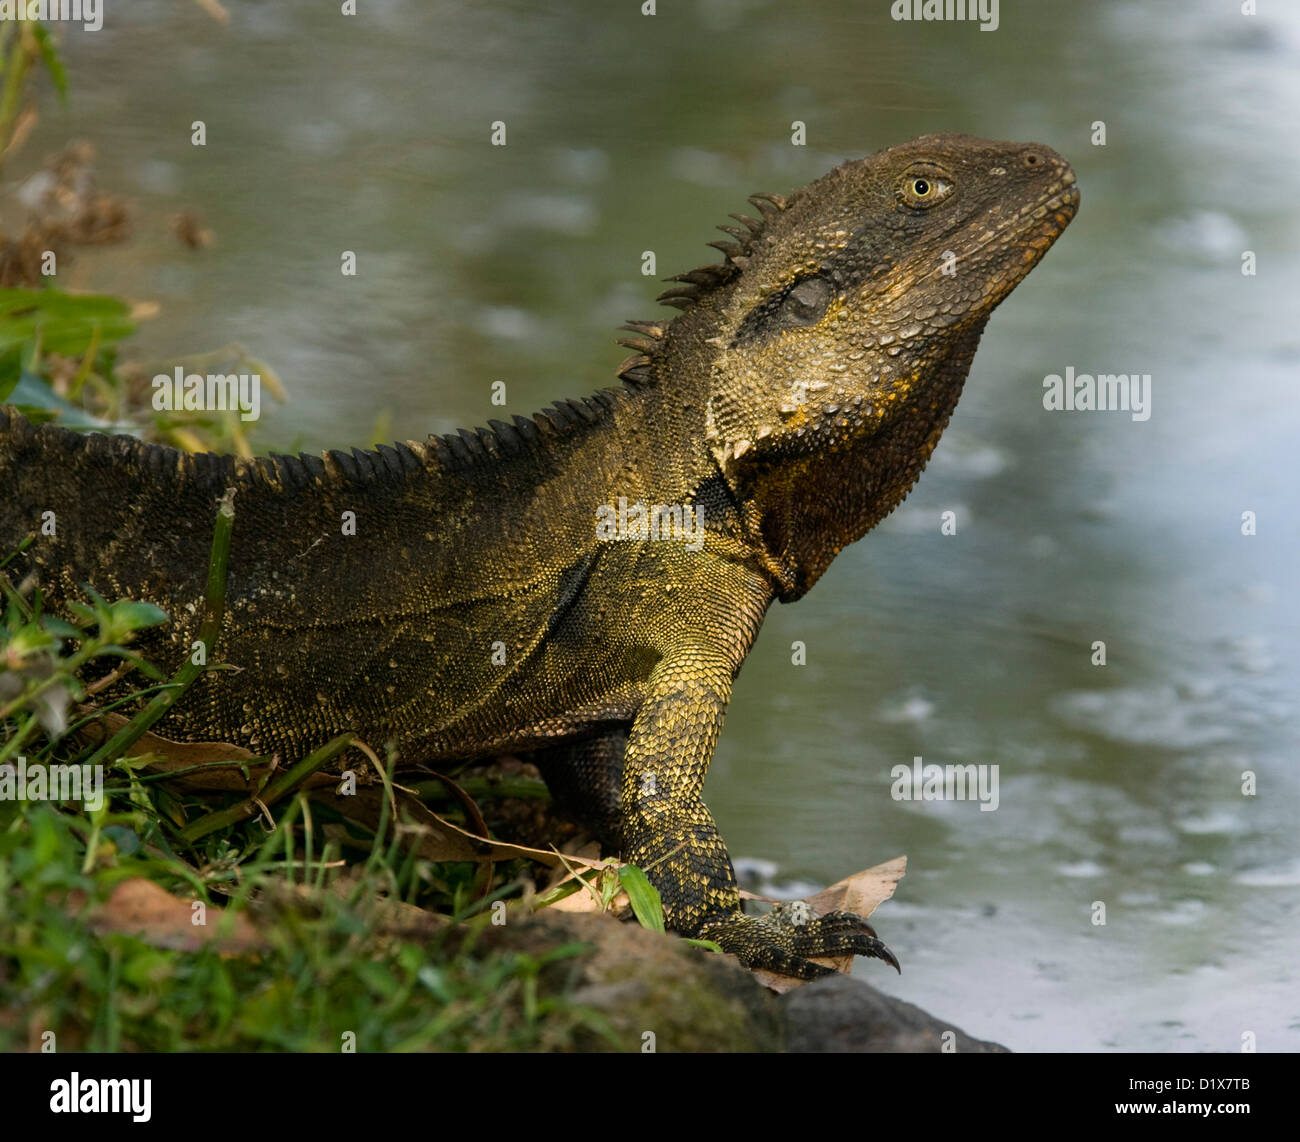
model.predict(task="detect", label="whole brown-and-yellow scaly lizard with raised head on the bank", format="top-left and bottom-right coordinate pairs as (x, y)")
top-left (0, 134), bottom-right (1079, 978)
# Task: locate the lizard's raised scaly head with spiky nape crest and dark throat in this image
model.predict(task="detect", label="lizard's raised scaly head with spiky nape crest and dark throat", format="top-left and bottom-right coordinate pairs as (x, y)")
top-left (621, 134), bottom-right (1079, 598)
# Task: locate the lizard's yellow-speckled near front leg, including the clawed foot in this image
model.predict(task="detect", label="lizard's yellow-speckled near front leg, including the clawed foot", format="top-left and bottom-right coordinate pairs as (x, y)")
top-left (623, 649), bottom-right (898, 979)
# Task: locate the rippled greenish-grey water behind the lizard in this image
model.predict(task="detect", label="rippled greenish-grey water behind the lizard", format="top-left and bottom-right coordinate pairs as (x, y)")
top-left (35, 0), bottom-right (1300, 1051)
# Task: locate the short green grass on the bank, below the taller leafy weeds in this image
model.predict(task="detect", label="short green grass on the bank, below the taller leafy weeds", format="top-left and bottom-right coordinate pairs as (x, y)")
top-left (0, 804), bottom-right (606, 1051)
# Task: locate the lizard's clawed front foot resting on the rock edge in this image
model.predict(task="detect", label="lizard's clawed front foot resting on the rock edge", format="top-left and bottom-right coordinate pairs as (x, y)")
top-left (699, 901), bottom-right (902, 979)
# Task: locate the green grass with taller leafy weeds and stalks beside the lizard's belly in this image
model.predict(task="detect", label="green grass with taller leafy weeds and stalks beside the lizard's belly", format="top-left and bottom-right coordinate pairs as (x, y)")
top-left (0, 512), bottom-right (624, 1051)
